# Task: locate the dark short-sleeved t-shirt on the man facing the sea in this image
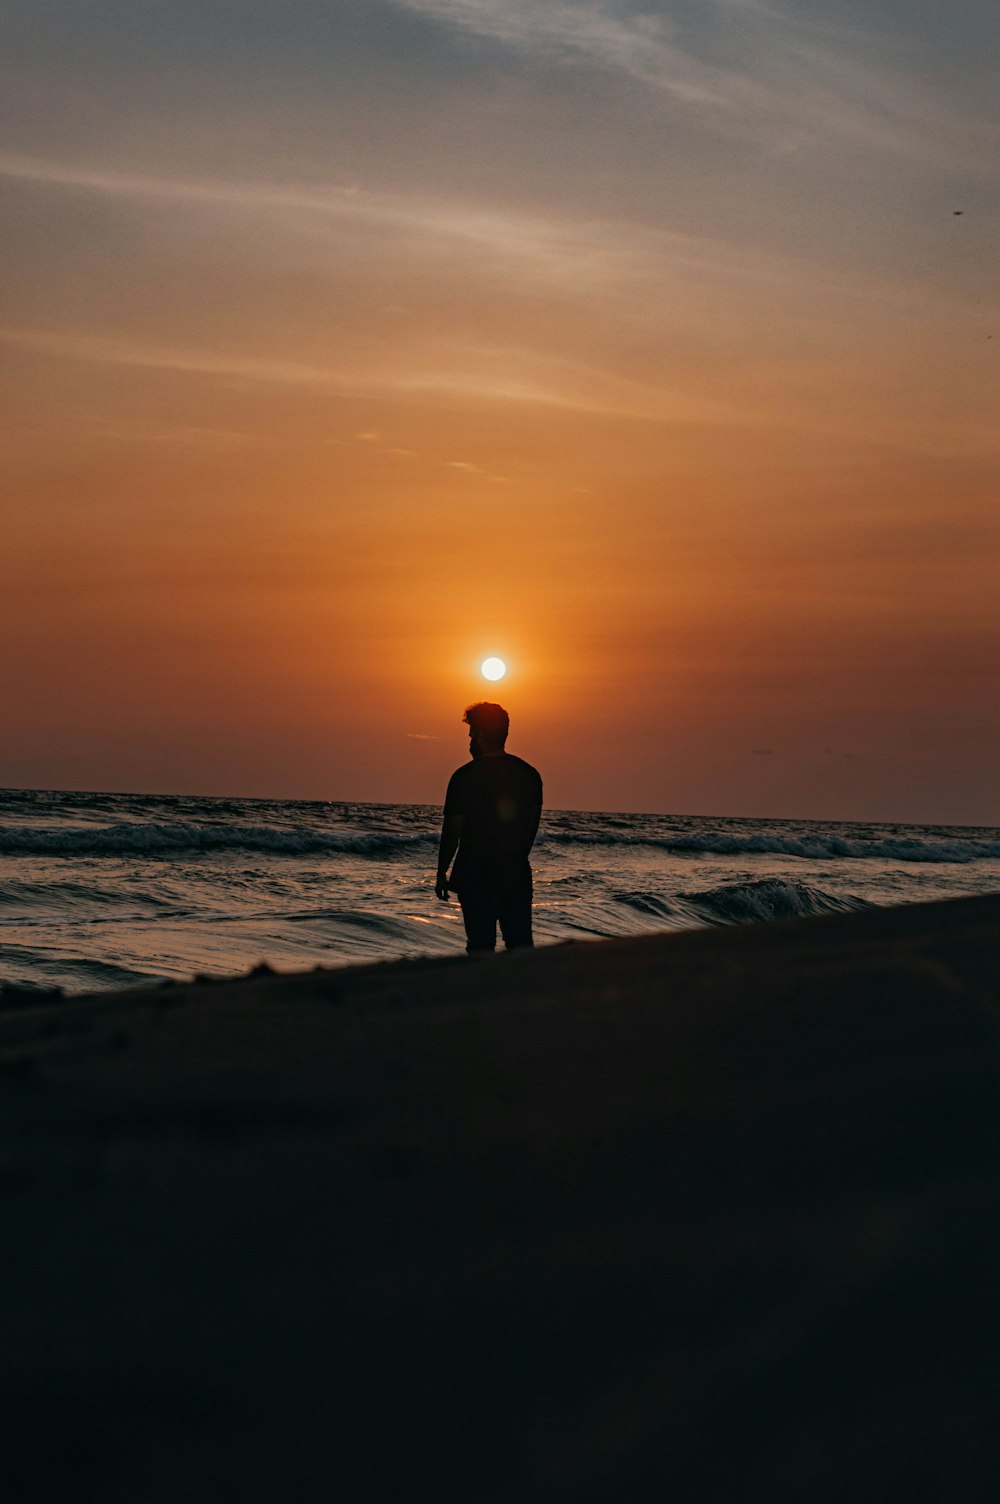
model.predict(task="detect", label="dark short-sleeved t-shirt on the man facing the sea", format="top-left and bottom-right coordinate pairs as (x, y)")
top-left (445, 752), bottom-right (541, 892)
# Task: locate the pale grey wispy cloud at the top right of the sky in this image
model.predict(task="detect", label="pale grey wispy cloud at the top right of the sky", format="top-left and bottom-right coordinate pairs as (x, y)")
top-left (394, 0), bottom-right (995, 167)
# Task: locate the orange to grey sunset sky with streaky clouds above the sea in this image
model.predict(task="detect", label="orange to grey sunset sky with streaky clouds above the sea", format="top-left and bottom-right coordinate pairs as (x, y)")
top-left (0, 0), bottom-right (1000, 824)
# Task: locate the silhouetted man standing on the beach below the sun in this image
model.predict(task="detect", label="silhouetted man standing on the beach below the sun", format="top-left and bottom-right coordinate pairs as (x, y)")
top-left (435, 701), bottom-right (541, 951)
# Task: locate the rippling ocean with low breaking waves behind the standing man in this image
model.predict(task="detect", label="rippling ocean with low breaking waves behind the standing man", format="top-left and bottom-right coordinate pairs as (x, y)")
top-left (0, 790), bottom-right (1000, 993)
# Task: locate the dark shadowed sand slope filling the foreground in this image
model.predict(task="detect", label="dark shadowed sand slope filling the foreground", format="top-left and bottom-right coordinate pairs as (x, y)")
top-left (0, 898), bottom-right (1000, 1504)
